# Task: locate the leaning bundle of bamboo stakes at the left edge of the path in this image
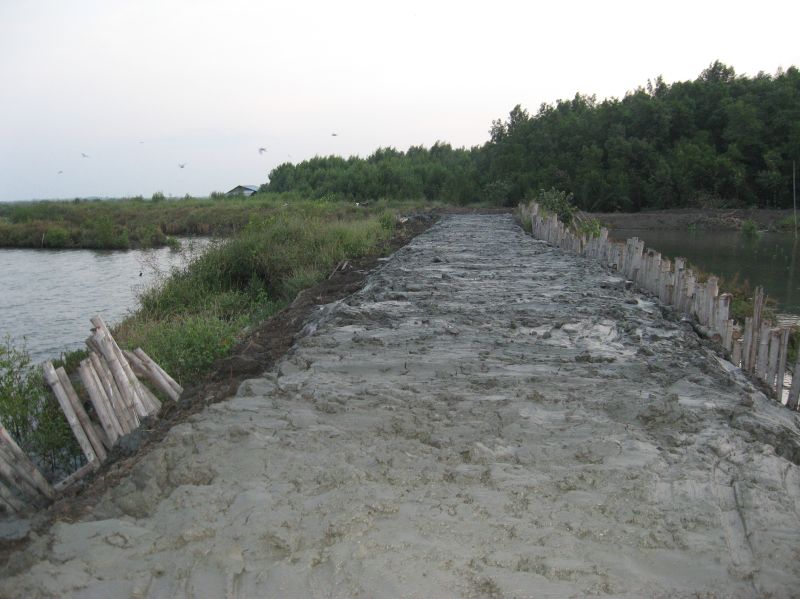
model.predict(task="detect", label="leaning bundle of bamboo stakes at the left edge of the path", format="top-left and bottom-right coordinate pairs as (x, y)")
top-left (0, 316), bottom-right (183, 513)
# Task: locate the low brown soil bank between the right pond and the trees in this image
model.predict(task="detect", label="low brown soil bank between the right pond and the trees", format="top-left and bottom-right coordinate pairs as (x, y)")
top-left (591, 209), bottom-right (792, 231)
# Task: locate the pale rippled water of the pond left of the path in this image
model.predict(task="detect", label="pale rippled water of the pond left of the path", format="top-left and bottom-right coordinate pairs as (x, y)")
top-left (0, 239), bottom-right (208, 362)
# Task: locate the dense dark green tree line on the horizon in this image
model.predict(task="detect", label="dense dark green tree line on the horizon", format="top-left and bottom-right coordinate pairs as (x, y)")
top-left (262, 61), bottom-right (800, 211)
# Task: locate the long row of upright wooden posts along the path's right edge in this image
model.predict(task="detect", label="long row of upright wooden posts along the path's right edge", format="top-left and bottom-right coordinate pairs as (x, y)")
top-left (524, 202), bottom-right (800, 410)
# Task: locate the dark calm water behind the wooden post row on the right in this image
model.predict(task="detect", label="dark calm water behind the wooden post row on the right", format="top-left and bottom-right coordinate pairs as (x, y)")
top-left (610, 229), bottom-right (800, 314)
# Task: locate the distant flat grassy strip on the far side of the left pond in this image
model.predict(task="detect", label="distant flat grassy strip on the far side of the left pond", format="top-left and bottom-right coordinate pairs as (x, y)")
top-left (0, 193), bottom-right (336, 249)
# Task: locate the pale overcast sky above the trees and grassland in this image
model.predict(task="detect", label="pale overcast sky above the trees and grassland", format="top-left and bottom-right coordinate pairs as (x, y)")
top-left (0, 0), bottom-right (800, 201)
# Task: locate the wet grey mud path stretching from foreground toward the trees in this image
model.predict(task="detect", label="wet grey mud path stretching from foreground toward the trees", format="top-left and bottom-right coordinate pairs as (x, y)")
top-left (0, 215), bottom-right (800, 598)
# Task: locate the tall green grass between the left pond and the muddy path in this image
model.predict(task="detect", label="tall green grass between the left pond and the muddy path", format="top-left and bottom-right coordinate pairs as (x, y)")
top-left (112, 202), bottom-right (395, 381)
